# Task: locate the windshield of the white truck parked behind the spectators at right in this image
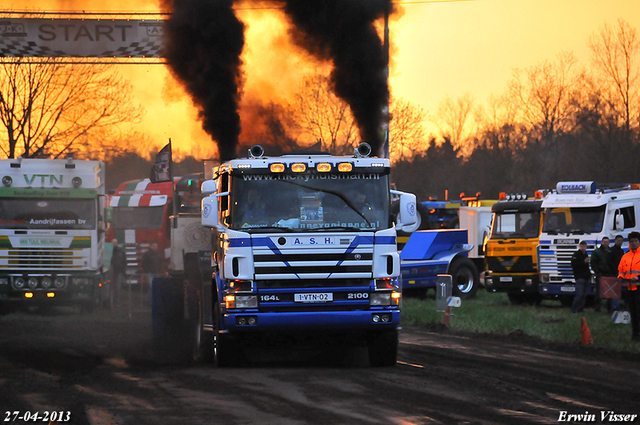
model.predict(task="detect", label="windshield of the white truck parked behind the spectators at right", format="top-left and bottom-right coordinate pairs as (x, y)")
top-left (542, 205), bottom-right (606, 235)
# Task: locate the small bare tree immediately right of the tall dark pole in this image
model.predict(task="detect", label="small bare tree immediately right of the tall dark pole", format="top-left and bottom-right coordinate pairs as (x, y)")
top-left (389, 97), bottom-right (425, 162)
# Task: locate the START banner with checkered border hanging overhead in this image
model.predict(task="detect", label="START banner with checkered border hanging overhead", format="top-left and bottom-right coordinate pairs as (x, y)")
top-left (0, 18), bottom-right (164, 58)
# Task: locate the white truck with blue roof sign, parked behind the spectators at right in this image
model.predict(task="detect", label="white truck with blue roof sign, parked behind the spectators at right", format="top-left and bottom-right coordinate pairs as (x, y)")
top-left (538, 181), bottom-right (640, 305)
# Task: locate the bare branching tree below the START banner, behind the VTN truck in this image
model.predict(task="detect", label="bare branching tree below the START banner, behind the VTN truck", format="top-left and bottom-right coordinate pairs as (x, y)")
top-left (0, 58), bottom-right (142, 158)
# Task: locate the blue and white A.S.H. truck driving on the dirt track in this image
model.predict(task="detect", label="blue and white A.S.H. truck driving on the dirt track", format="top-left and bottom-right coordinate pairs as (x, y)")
top-left (198, 144), bottom-right (416, 366)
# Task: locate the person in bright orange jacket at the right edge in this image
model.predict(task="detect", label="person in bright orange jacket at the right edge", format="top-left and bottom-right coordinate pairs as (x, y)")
top-left (618, 232), bottom-right (640, 341)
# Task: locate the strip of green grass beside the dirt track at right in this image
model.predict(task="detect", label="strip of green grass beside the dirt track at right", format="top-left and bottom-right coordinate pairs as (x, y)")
top-left (402, 289), bottom-right (640, 353)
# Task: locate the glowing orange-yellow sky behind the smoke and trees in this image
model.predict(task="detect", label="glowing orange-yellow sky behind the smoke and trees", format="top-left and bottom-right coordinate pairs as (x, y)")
top-left (3, 0), bottom-right (640, 158)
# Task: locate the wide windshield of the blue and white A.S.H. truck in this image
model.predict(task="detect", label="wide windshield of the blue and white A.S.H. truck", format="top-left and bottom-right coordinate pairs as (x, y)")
top-left (230, 174), bottom-right (390, 231)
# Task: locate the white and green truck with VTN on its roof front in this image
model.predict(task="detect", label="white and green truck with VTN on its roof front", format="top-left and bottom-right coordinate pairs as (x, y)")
top-left (0, 157), bottom-right (108, 312)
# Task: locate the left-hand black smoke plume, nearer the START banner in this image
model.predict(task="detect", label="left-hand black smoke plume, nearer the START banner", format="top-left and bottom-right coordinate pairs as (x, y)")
top-left (163, 0), bottom-right (244, 161)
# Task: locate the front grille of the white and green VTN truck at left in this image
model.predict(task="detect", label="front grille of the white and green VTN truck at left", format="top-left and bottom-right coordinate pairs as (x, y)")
top-left (0, 248), bottom-right (87, 270)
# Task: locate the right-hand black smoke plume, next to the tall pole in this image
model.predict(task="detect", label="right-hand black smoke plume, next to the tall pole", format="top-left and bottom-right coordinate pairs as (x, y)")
top-left (284, 0), bottom-right (393, 156)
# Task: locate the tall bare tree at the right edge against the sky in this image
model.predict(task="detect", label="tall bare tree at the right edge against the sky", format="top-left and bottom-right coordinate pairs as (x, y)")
top-left (589, 19), bottom-right (640, 132)
